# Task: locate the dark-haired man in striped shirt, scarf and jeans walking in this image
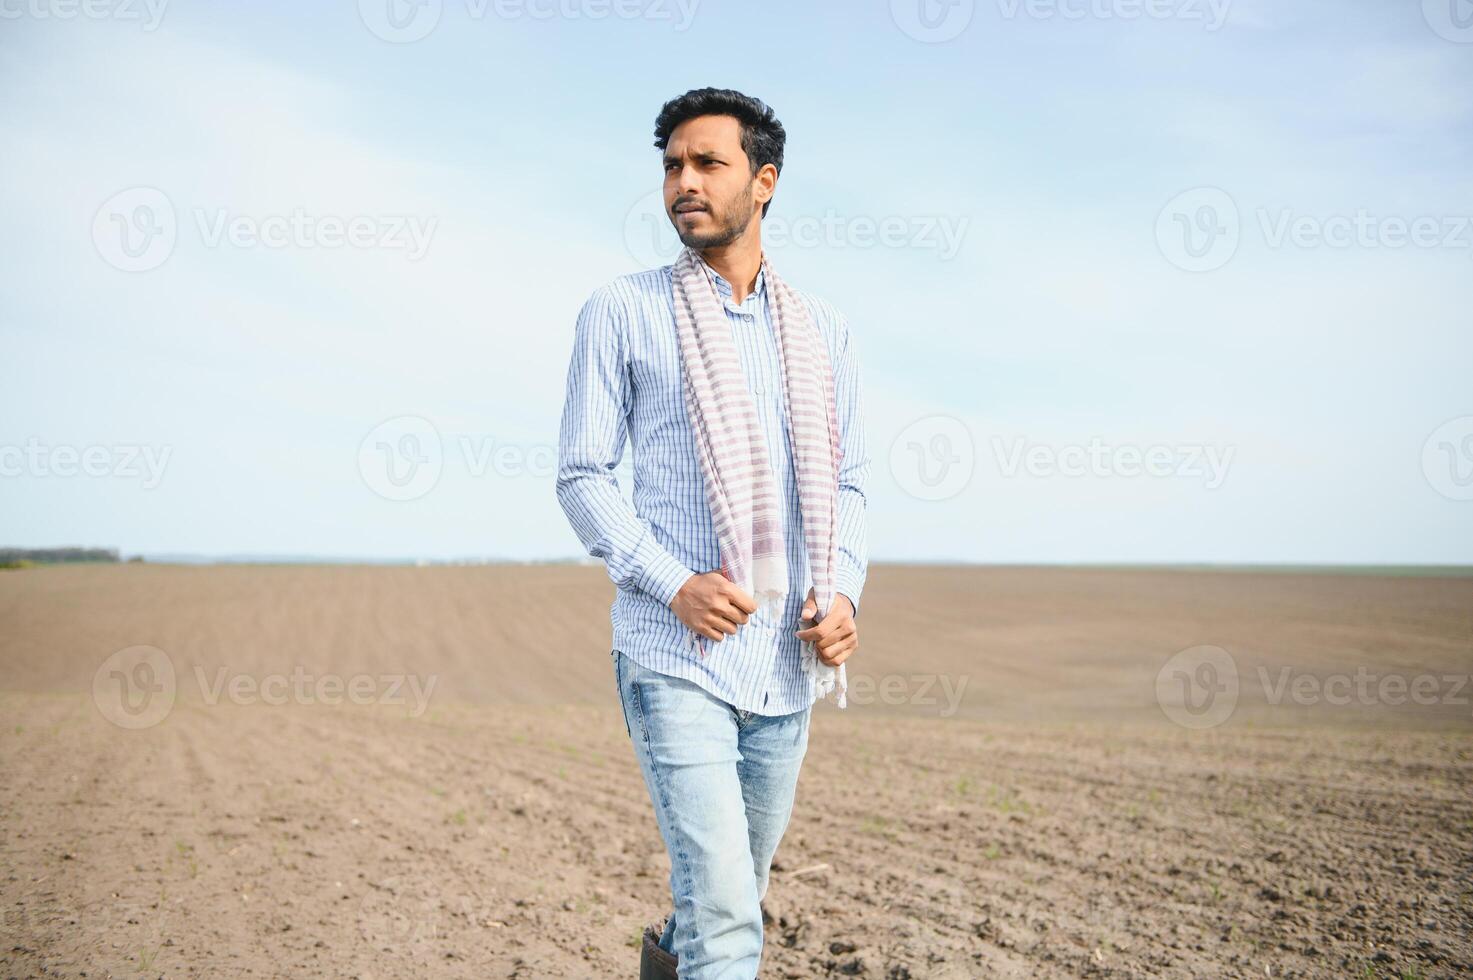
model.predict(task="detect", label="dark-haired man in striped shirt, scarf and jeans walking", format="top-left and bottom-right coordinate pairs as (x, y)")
top-left (557, 88), bottom-right (871, 980)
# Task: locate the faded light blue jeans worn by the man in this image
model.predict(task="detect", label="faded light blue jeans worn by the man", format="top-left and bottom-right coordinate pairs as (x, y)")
top-left (613, 650), bottom-right (813, 980)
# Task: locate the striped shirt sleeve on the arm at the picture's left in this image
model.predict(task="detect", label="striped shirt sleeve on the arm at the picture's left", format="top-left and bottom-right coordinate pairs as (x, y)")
top-left (557, 286), bottom-right (695, 606)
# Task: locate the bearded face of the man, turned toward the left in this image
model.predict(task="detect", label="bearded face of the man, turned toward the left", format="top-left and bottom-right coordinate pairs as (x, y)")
top-left (664, 116), bottom-right (776, 249)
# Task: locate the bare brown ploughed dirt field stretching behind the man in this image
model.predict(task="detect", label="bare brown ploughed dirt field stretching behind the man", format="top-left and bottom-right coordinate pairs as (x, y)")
top-left (0, 564), bottom-right (1473, 980)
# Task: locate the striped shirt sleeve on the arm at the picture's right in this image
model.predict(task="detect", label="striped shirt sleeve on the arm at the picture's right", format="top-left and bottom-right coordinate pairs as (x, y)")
top-left (834, 315), bottom-right (871, 619)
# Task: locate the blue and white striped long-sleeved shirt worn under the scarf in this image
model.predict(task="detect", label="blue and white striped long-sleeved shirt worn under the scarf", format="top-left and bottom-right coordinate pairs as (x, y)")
top-left (557, 253), bottom-right (871, 715)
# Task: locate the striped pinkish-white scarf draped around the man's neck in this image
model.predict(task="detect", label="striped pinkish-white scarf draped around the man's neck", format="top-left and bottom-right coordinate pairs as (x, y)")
top-left (673, 248), bottom-right (848, 707)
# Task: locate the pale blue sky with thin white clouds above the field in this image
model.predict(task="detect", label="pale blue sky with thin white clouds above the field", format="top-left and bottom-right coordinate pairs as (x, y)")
top-left (0, 0), bottom-right (1473, 564)
